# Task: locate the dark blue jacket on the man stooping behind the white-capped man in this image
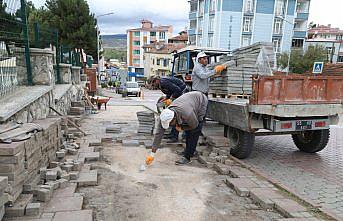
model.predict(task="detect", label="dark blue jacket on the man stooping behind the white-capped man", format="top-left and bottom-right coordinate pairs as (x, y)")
top-left (160, 77), bottom-right (186, 99)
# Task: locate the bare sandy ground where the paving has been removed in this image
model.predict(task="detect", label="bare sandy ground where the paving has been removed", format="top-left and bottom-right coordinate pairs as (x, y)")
top-left (79, 106), bottom-right (281, 221)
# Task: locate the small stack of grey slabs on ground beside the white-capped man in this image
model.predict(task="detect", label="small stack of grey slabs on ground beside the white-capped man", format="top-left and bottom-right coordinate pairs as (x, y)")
top-left (137, 111), bottom-right (155, 135)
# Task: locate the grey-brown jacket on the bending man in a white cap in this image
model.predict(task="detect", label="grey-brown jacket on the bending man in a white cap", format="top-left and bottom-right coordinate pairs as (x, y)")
top-left (152, 91), bottom-right (208, 148)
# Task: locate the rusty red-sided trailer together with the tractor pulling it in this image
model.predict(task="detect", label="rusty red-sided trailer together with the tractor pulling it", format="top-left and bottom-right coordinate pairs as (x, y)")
top-left (173, 47), bottom-right (343, 159)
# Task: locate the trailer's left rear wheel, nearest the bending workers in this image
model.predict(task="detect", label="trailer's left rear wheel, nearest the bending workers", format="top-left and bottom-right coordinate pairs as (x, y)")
top-left (229, 127), bottom-right (255, 159)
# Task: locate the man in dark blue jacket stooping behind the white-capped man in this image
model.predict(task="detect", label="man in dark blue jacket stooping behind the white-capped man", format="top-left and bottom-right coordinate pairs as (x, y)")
top-left (159, 77), bottom-right (188, 143)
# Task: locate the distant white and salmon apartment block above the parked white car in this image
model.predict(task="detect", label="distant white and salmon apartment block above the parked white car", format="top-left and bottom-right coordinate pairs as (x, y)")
top-left (127, 20), bottom-right (173, 76)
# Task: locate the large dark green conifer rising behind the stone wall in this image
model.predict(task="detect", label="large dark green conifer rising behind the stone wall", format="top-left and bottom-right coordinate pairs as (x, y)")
top-left (45, 0), bottom-right (97, 58)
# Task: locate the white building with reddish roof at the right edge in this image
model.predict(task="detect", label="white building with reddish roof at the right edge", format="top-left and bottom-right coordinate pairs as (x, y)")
top-left (306, 25), bottom-right (343, 64)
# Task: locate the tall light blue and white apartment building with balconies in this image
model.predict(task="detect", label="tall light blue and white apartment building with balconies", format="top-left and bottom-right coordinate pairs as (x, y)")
top-left (188, 0), bottom-right (310, 53)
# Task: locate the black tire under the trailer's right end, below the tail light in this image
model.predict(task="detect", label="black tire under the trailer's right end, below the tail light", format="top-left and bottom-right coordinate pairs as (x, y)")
top-left (292, 129), bottom-right (330, 153)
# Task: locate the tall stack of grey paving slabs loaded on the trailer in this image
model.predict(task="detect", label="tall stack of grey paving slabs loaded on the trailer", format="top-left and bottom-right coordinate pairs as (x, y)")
top-left (210, 42), bottom-right (276, 95)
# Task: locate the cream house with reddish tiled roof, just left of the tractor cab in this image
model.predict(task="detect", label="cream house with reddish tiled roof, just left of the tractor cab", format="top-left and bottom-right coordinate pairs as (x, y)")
top-left (143, 42), bottom-right (186, 78)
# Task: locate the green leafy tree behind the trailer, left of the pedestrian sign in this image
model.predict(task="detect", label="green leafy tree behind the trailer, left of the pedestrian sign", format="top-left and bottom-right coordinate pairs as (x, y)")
top-left (278, 45), bottom-right (327, 74)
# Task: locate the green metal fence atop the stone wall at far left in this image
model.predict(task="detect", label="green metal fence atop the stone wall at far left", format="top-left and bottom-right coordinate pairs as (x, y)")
top-left (0, 0), bottom-right (32, 98)
